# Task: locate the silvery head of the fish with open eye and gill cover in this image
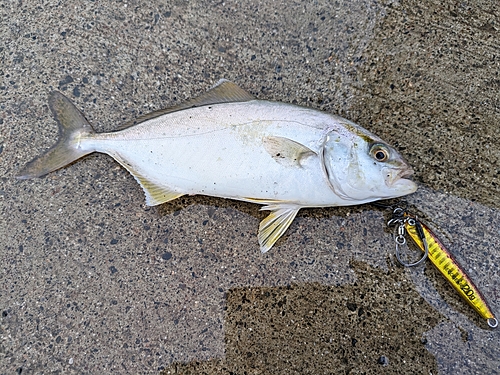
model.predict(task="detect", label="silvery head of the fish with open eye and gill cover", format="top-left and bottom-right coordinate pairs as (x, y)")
top-left (323, 124), bottom-right (417, 204)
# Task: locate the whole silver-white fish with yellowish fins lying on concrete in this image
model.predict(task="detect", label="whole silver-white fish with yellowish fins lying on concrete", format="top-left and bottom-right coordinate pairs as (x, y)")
top-left (17, 79), bottom-right (417, 253)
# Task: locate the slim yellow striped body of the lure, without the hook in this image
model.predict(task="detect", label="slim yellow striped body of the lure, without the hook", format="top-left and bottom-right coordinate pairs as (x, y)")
top-left (405, 215), bottom-right (498, 328)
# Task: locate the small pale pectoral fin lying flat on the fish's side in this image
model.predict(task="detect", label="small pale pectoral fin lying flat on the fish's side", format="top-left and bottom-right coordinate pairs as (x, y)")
top-left (263, 136), bottom-right (317, 167)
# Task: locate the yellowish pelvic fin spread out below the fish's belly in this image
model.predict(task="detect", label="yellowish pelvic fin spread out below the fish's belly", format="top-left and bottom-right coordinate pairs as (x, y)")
top-left (258, 203), bottom-right (300, 253)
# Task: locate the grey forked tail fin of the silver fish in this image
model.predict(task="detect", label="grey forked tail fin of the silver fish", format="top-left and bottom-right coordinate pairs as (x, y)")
top-left (17, 91), bottom-right (95, 179)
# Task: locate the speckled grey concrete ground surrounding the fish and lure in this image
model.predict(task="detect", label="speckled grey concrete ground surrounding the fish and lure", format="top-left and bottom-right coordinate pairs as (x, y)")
top-left (0, 0), bottom-right (500, 375)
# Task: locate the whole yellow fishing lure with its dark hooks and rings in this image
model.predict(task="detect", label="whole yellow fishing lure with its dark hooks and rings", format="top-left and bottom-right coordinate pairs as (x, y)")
top-left (389, 208), bottom-right (498, 328)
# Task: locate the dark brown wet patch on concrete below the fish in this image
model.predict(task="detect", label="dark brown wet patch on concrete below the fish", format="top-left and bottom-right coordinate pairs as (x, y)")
top-left (162, 262), bottom-right (443, 375)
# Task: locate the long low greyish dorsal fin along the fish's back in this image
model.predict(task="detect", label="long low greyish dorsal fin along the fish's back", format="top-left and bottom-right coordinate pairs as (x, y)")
top-left (113, 79), bottom-right (255, 131)
